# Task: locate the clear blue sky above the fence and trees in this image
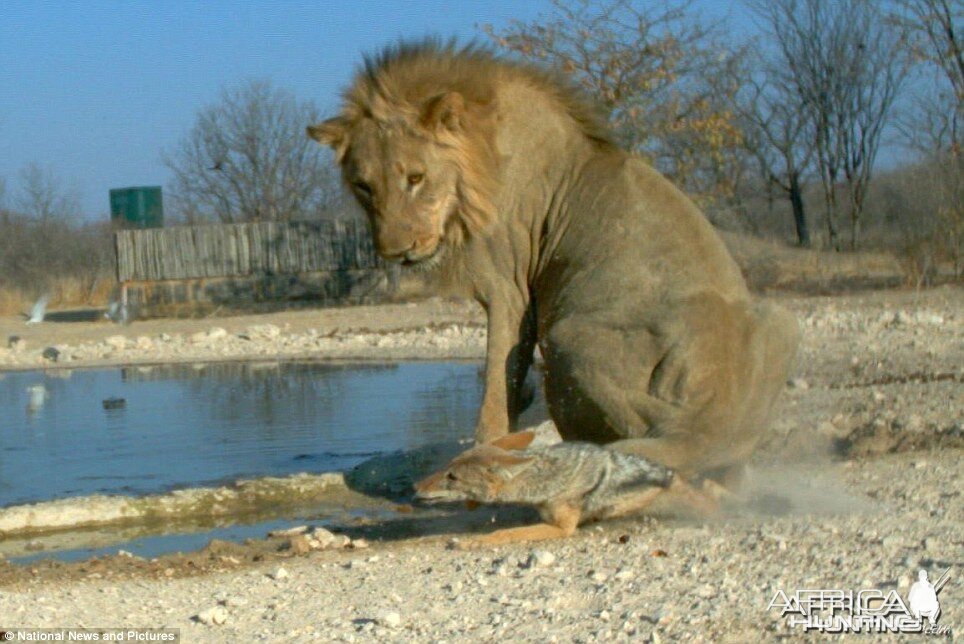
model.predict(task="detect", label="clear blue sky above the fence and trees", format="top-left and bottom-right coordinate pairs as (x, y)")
top-left (0, 0), bottom-right (748, 218)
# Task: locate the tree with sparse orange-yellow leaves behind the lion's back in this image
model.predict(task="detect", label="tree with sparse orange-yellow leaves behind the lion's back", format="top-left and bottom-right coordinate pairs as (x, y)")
top-left (485, 0), bottom-right (743, 204)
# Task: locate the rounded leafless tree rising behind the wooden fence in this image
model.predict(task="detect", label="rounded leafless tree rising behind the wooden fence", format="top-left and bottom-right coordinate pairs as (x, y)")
top-left (163, 81), bottom-right (341, 223)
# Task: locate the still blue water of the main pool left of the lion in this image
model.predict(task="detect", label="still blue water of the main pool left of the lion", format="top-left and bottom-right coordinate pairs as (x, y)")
top-left (0, 362), bottom-right (481, 507)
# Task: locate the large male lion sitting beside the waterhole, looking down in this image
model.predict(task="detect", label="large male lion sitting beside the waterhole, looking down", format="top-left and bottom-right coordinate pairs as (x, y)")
top-left (308, 41), bottom-right (799, 480)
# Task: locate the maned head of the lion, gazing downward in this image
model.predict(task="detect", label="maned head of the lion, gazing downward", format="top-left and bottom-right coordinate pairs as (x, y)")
top-left (308, 41), bottom-right (498, 265)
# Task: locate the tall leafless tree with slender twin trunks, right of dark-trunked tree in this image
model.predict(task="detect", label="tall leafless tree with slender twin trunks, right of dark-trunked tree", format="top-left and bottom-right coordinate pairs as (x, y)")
top-left (747, 0), bottom-right (907, 250)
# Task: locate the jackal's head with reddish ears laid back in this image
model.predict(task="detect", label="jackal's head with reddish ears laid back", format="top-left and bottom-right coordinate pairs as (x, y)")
top-left (415, 432), bottom-right (534, 503)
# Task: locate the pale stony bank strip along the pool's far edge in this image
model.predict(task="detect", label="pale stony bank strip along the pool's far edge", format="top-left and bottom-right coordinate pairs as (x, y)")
top-left (0, 298), bottom-right (485, 370)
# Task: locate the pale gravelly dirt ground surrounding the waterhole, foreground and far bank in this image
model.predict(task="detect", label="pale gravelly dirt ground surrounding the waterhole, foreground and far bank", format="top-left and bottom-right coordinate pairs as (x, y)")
top-left (0, 286), bottom-right (964, 642)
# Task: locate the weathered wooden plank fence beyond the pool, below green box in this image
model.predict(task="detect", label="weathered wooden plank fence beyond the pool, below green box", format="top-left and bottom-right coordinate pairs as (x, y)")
top-left (115, 221), bottom-right (398, 315)
